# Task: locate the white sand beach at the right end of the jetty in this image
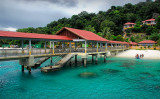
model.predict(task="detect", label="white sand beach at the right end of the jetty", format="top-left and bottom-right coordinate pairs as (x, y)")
top-left (116, 50), bottom-right (160, 59)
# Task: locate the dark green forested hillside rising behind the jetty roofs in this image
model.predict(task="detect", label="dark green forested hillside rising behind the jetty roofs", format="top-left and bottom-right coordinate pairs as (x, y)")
top-left (17, 1), bottom-right (160, 39)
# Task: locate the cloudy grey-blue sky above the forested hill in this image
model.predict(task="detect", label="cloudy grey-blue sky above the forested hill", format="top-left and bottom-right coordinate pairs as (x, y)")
top-left (0, 0), bottom-right (146, 31)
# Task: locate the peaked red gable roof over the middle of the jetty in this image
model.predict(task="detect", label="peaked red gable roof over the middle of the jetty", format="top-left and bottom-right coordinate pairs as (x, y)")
top-left (56, 27), bottom-right (109, 42)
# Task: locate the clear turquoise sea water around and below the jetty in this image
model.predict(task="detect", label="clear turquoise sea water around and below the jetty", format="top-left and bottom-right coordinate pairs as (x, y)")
top-left (0, 58), bottom-right (160, 99)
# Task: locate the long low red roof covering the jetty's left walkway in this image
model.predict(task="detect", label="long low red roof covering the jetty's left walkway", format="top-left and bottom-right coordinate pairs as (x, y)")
top-left (0, 31), bottom-right (72, 40)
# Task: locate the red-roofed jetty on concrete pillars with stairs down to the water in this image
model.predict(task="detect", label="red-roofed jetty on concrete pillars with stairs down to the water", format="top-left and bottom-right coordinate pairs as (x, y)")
top-left (0, 27), bottom-right (129, 72)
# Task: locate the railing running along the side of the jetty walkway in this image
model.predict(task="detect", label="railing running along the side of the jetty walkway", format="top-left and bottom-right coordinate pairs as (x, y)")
top-left (0, 47), bottom-right (127, 57)
